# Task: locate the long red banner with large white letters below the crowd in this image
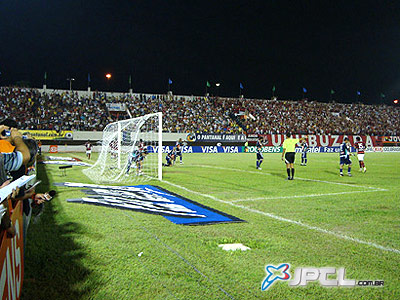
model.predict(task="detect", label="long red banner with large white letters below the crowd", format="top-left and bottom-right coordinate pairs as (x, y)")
top-left (252, 134), bottom-right (382, 147)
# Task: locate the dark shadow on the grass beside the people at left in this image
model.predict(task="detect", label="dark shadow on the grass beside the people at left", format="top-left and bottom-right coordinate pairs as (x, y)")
top-left (21, 165), bottom-right (96, 300)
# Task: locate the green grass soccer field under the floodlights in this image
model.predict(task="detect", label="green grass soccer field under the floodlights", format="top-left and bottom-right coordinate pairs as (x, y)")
top-left (22, 153), bottom-right (400, 300)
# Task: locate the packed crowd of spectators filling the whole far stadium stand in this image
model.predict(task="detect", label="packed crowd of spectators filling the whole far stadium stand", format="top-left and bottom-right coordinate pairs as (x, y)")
top-left (0, 87), bottom-right (400, 135)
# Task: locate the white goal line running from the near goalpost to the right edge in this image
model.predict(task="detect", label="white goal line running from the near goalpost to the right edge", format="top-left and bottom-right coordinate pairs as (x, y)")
top-left (163, 180), bottom-right (400, 254)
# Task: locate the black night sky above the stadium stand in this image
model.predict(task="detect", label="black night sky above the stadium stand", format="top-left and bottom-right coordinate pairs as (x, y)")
top-left (0, 0), bottom-right (400, 103)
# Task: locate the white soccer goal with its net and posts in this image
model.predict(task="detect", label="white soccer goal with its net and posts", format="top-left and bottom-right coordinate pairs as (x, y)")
top-left (83, 112), bottom-right (162, 183)
